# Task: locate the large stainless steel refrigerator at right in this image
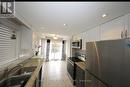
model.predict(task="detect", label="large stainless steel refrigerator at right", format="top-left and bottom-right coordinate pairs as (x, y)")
top-left (85, 39), bottom-right (130, 87)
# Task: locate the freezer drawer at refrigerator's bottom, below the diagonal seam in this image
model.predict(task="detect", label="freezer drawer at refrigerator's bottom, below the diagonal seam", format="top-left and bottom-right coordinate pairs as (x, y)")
top-left (85, 70), bottom-right (108, 87)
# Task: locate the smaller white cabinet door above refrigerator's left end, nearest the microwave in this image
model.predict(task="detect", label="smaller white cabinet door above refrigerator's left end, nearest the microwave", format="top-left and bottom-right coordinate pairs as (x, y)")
top-left (86, 26), bottom-right (100, 42)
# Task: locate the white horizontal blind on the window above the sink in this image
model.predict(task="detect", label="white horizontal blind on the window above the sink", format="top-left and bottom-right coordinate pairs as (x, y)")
top-left (0, 24), bottom-right (16, 65)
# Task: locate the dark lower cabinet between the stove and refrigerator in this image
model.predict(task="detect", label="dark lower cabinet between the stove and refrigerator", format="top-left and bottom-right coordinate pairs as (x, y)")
top-left (75, 66), bottom-right (85, 87)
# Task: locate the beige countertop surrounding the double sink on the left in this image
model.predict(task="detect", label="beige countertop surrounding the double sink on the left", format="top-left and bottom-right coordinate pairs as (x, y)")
top-left (0, 58), bottom-right (44, 87)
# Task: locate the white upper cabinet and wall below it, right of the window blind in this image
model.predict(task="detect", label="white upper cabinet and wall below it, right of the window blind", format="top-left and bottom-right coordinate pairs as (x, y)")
top-left (19, 25), bottom-right (33, 58)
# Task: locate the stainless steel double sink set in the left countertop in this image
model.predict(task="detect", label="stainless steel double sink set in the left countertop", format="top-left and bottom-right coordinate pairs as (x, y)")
top-left (0, 65), bottom-right (36, 87)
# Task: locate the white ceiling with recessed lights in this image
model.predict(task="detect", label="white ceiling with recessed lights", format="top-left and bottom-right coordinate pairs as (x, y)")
top-left (15, 2), bottom-right (130, 36)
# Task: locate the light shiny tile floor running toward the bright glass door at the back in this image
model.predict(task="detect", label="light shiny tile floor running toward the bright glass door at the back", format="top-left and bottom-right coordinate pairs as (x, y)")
top-left (42, 61), bottom-right (74, 87)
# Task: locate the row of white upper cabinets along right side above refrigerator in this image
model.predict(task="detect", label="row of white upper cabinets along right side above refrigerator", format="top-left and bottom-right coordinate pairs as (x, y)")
top-left (73, 13), bottom-right (130, 50)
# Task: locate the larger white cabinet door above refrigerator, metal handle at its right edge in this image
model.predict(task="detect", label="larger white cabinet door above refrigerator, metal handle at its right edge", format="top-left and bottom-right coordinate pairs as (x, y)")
top-left (101, 16), bottom-right (125, 40)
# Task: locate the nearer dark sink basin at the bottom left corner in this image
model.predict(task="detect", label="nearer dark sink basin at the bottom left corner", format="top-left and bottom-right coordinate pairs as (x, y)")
top-left (0, 74), bottom-right (31, 87)
